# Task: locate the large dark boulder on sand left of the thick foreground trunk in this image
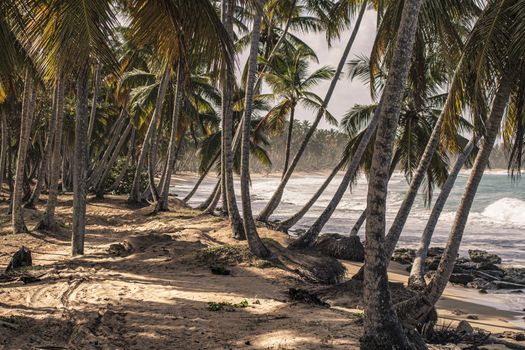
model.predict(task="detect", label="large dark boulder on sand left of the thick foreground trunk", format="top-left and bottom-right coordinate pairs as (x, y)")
top-left (315, 233), bottom-right (365, 262)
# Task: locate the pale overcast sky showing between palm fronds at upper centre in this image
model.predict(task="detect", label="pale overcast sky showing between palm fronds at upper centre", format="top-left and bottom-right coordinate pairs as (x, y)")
top-left (240, 11), bottom-right (376, 129)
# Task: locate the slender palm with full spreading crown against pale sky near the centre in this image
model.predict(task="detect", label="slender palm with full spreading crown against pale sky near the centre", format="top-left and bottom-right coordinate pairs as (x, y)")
top-left (262, 45), bottom-right (337, 176)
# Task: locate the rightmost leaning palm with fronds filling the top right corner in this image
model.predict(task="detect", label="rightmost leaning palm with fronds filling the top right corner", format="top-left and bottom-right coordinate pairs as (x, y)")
top-left (396, 0), bottom-right (525, 326)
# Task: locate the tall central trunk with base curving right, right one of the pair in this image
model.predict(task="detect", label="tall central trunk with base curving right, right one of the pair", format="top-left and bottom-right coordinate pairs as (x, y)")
top-left (241, 0), bottom-right (271, 258)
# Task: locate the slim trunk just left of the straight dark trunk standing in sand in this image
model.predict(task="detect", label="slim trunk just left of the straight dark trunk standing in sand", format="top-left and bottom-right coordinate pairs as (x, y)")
top-left (36, 74), bottom-right (65, 230)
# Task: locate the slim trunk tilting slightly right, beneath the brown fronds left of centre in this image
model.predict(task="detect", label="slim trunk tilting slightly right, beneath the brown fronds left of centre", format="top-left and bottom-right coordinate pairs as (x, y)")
top-left (155, 61), bottom-right (185, 212)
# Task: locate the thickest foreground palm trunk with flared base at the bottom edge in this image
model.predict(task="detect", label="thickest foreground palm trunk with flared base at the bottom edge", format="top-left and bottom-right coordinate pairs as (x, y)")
top-left (360, 0), bottom-right (423, 349)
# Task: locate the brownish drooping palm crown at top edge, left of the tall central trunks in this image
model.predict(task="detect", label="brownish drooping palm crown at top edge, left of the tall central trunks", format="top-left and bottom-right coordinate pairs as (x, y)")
top-left (125, 0), bottom-right (233, 79)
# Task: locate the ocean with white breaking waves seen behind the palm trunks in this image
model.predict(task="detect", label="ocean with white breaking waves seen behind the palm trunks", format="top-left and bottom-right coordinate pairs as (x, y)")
top-left (172, 171), bottom-right (525, 267)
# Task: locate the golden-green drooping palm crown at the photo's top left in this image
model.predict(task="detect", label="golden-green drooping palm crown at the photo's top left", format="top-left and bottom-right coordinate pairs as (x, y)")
top-left (27, 0), bottom-right (117, 78)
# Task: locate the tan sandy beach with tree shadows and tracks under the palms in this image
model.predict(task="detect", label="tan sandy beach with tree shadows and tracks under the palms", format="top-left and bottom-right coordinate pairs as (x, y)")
top-left (0, 195), bottom-right (525, 349)
